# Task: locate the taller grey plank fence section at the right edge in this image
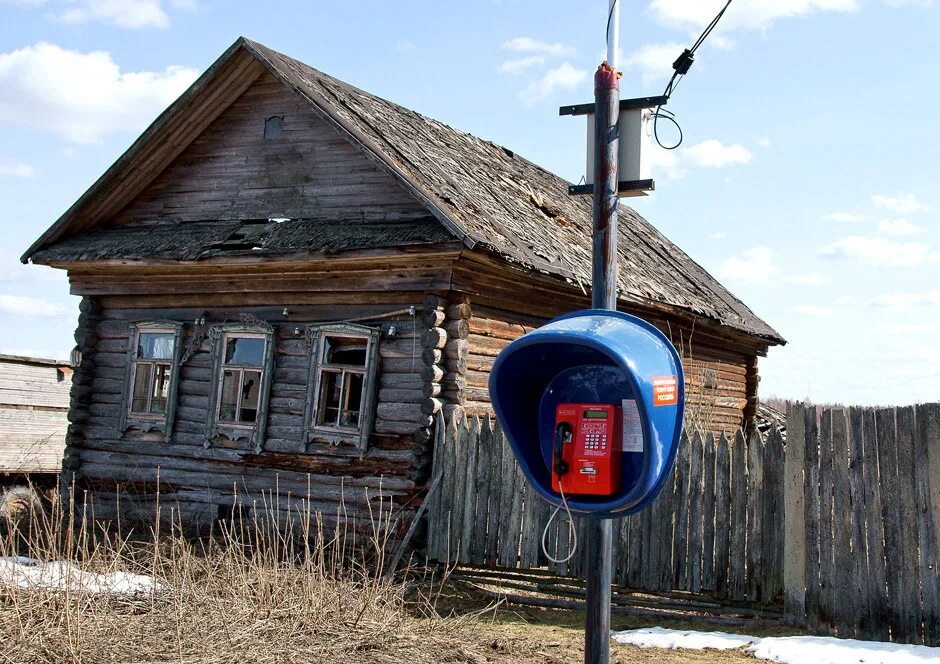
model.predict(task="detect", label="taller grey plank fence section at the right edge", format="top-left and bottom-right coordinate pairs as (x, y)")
top-left (785, 404), bottom-right (940, 645)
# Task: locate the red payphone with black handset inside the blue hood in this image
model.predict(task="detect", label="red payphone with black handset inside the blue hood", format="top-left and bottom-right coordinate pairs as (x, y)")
top-left (552, 403), bottom-right (623, 496)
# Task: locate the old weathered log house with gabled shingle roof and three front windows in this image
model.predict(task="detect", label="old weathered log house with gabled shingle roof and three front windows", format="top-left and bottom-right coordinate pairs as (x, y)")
top-left (23, 38), bottom-right (783, 523)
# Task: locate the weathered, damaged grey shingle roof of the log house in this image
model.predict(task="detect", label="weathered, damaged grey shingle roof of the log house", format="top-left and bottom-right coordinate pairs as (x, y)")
top-left (26, 38), bottom-right (784, 343)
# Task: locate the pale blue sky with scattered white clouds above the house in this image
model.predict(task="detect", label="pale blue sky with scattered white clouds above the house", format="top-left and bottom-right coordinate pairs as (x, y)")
top-left (0, 0), bottom-right (940, 405)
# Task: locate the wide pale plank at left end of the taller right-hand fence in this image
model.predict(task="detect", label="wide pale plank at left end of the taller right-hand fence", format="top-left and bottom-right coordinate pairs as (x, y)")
top-left (781, 403), bottom-right (806, 625)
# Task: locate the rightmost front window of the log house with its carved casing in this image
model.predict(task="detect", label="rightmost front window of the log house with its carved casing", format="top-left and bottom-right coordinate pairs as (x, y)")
top-left (304, 323), bottom-right (380, 451)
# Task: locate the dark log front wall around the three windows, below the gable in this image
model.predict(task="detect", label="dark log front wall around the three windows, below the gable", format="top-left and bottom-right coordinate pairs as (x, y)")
top-left (65, 294), bottom-right (447, 527)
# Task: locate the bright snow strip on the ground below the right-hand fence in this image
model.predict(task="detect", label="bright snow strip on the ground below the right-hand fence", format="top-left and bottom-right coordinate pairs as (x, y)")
top-left (612, 627), bottom-right (940, 664)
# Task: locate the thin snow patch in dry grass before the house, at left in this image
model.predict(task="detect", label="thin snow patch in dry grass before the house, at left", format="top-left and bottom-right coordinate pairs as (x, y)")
top-left (0, 556), bottom-right (161, 595)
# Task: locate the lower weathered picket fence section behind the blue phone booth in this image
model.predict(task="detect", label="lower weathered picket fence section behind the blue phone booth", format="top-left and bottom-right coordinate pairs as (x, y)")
top-left (428, 410), bottom-right (783, 603)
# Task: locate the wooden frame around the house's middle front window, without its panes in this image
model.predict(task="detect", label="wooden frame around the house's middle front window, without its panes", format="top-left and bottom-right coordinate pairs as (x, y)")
top-left (205, 323), bottom-right (275, 453)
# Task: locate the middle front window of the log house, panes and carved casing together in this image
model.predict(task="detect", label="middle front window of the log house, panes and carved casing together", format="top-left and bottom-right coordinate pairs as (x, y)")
top-left (206, 323), bottom-right (274, 452)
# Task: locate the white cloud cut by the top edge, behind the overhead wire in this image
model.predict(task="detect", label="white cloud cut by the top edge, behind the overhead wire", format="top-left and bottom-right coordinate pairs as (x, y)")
top-left (649, 0), bottom-right (860, 31)
